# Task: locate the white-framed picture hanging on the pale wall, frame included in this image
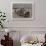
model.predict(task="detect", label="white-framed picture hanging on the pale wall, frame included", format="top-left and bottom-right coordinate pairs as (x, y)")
top-left (12, 2), bottom-right (35, 20)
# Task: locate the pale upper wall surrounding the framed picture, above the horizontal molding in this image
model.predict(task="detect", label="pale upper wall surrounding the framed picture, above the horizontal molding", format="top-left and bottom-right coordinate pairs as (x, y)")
top-left (0, 0), bottom-right (46, 30)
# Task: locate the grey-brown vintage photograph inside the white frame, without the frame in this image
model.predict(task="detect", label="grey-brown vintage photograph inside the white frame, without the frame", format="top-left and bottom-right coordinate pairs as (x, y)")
top-left (12, 3), bottom-right (32, 18)
